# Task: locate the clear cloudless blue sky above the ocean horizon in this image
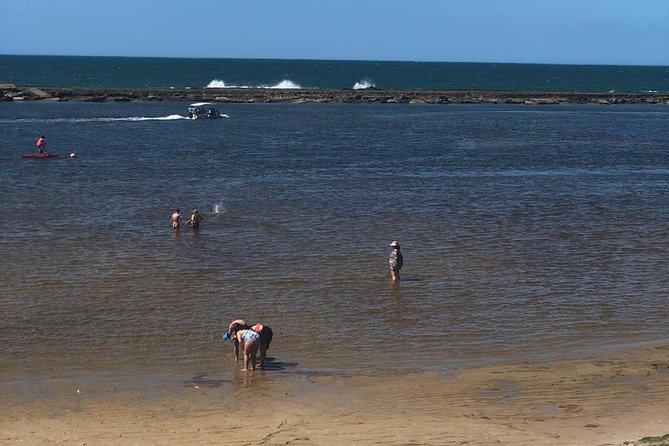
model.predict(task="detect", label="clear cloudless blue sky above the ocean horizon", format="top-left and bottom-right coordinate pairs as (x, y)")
top-left (0, 0), bottom-right (669, 65)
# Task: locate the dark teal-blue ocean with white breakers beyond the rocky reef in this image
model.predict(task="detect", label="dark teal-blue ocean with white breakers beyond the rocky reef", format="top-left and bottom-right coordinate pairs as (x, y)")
top-left (0, 55), bottom-right (669, 93)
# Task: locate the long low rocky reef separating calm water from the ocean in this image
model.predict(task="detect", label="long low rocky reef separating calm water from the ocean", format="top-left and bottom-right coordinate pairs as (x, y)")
top-left (0, 84), bottom-right (669, 105)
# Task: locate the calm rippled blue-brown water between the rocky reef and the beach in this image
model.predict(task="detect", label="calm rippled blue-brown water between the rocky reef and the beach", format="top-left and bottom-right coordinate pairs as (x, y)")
top-left (0, 56), bottom-right (669, 386)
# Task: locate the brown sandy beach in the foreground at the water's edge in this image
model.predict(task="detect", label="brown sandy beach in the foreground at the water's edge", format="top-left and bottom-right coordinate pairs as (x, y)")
top-left (0, 345), bottom-right (669, 445)
